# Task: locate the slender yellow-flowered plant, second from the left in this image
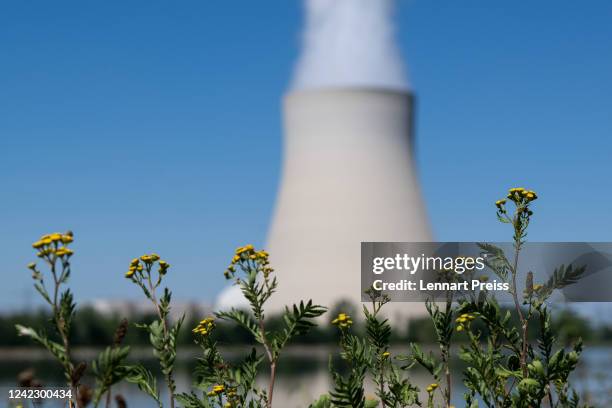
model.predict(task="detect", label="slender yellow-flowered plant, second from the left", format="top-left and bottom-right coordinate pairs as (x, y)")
top-left (125, 254), bottom-right (184, 408)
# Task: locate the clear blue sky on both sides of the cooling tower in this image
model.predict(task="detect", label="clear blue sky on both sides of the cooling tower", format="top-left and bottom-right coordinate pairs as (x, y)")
top-left (0, 0), bottom-right (612, 310)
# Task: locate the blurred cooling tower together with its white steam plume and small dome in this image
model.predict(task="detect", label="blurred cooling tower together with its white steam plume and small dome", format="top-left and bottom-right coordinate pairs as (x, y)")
top-left (217, 0), bottom-right (432, 315)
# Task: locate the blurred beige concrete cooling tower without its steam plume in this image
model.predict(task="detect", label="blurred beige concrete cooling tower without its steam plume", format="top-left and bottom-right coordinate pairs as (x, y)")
top-left (267, 88), bottom-right (431, 314)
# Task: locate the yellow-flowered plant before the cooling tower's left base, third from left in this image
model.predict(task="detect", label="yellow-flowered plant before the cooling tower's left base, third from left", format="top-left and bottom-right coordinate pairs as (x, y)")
top-left (179, 245), bottom-right (326, 408)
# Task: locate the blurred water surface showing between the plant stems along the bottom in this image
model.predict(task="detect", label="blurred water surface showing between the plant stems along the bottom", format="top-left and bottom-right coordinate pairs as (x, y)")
top-left (0, 347), bottom-right (612, 408)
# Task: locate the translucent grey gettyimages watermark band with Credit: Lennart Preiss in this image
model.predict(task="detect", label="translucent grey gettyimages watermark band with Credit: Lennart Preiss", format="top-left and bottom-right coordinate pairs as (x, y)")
top-left (361, 242), bottom-right (612, 303)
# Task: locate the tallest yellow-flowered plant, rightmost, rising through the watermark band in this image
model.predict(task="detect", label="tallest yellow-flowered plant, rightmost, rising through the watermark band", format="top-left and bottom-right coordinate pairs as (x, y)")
top-left (413, 188), bottom-right (584, 408)
